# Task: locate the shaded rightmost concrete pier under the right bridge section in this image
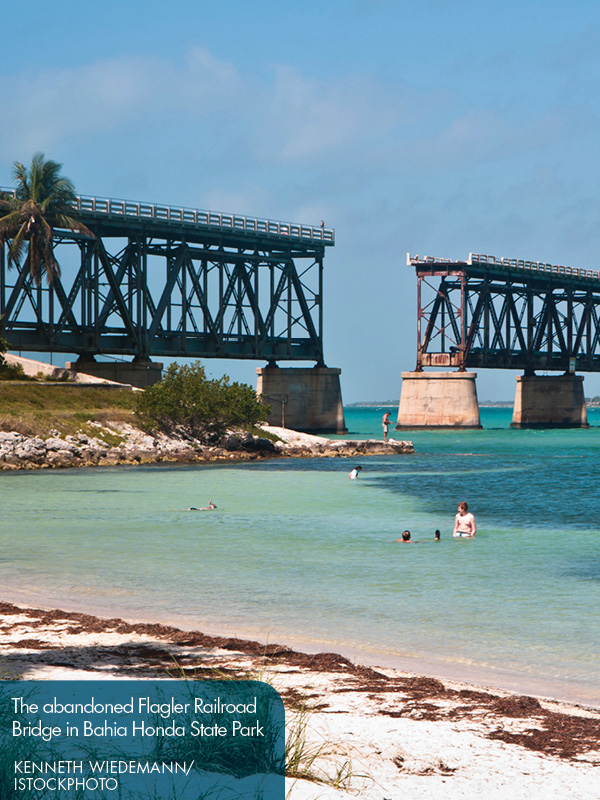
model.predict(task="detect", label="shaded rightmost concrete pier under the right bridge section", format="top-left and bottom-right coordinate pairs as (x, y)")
top-left (510, 375), bottom-right (589, 428)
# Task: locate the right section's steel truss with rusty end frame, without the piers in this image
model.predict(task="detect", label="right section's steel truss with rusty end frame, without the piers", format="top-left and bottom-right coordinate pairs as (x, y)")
top-left (407, 253), bottom-right (600, 374)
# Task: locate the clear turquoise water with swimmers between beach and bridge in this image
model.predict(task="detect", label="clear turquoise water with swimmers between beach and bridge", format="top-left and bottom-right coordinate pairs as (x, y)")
top-left (0, 409), bottom-right (600, 705)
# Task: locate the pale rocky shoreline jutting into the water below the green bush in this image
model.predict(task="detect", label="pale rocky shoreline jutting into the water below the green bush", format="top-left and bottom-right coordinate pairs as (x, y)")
top-left (0, 422), bottom-right (414, 470)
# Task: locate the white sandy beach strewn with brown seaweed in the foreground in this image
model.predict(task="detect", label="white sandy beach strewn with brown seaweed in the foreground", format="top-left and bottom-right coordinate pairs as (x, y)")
top-left (0, 603), bottom-right (600, 800)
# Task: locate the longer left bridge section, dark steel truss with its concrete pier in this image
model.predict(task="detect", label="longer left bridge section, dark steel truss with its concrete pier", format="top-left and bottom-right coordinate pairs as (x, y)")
top-left (0, 189), bottom-right (345, 432)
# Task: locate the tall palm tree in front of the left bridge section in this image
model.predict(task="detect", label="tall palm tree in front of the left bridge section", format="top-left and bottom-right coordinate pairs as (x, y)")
top-left (0, 153), bottom-right (94, 286)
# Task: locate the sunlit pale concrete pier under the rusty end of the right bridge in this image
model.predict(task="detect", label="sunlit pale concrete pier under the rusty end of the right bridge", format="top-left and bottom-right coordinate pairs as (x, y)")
top-left (396, 372), bottom-right (481, 430)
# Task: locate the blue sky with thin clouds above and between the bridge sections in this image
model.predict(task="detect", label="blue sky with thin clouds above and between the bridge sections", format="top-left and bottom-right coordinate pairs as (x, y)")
top-left (0, 0), bottom-right (600, 402)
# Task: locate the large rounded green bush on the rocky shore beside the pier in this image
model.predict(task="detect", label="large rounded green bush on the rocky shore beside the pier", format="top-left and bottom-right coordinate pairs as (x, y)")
top-left (136, 361), bottom-right (270, 440)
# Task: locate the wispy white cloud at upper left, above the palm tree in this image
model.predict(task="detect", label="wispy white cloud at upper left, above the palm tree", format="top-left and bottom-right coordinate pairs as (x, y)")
top-left (0, 48), bottom-right (241, 153)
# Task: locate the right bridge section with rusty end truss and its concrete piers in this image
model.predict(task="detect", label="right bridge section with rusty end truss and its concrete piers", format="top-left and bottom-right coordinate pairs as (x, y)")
top-left (398, 253), bottom-right (600, 428)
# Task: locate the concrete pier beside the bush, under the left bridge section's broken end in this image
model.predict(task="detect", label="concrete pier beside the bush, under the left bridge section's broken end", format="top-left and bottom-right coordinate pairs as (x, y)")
top-left (256, 367), bottom-right (348, 433)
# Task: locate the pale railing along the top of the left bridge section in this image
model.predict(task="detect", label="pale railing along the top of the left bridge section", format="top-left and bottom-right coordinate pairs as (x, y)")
top-left (0, 187), bottom-right (335, 244)
